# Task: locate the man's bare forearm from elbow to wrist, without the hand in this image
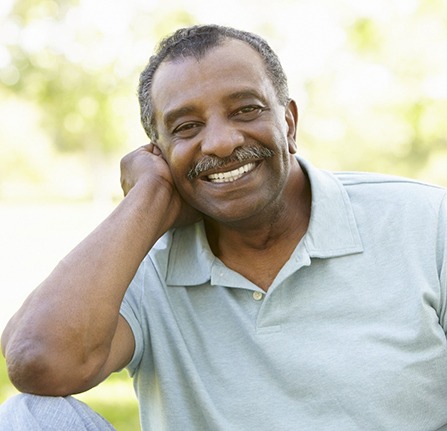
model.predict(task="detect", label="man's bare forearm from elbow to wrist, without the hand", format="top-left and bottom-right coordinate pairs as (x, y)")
top-left (2, 181), bottom-right (177, 392)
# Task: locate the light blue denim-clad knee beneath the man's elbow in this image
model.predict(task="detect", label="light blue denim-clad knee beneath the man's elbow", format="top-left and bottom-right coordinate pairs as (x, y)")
top-left (0, 394), bottom-right (115, 431)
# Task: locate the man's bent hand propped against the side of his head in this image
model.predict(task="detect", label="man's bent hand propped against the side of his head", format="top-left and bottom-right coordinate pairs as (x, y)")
top-left (121, 143), bottom-right (202, 231)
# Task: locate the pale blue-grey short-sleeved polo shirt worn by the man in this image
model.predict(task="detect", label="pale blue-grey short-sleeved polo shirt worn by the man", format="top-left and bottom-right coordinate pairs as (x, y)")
top-left (121, 159), bottom-right (447, 431)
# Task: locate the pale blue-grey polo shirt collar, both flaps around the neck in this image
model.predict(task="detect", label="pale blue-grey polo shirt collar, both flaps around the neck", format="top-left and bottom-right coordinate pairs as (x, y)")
top-left (166, 158), bottom-right (363, 286)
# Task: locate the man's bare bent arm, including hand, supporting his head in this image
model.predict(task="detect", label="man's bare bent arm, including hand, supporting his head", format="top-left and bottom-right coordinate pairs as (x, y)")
top-left (2, 145), bottom-right (197, 395)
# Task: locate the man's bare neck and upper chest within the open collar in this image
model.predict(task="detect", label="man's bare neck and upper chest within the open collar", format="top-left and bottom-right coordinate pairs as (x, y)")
top-left (205, 164), bottom-right (311, 290)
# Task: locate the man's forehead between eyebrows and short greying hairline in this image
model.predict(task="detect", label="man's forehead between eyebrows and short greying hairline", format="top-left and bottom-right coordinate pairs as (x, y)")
top-left (152, 39), bottom-right (274, 123)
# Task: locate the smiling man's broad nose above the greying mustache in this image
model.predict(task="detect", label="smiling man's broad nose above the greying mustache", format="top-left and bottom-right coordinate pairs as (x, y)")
top-left (201, 119), bottom-right (244, 158)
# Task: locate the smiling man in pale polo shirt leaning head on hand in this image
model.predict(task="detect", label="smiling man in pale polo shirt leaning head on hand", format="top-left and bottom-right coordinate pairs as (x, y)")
top-left (0, 26), bottom-right (447, 431)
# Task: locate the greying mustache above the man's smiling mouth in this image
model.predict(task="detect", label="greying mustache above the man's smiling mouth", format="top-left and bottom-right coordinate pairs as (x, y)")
top-left (187, 145), bottom-right (275, 181)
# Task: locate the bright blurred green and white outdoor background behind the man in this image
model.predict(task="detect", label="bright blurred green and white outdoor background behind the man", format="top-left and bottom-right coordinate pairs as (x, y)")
top-left (0, 0), bottom-right (447, 431)
